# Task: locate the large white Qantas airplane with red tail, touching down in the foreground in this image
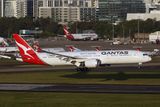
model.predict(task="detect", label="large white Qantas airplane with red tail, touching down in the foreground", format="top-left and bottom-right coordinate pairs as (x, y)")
top-left (13, 34), bottom-right (151, 71)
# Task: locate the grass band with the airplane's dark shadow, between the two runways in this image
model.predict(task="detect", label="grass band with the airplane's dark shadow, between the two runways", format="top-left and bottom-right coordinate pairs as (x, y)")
top-left (0, 71), bottom-right (160, 85)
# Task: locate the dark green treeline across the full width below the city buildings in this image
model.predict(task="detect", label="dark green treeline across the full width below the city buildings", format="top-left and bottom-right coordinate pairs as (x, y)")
top-left (0, 17), bottom-right (160, 38)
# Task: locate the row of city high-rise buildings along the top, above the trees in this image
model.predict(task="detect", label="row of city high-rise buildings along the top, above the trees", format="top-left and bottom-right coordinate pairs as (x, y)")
top-left (0, 0), bottom-right (160, 22)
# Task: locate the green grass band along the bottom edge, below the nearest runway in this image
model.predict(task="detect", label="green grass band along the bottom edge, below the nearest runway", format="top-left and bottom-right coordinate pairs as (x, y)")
top-left (0, 92), bottom-right (160, 107)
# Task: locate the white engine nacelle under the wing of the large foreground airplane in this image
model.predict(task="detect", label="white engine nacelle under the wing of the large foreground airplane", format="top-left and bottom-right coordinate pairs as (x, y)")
top-left (83, 59), bottom-right (101, 68)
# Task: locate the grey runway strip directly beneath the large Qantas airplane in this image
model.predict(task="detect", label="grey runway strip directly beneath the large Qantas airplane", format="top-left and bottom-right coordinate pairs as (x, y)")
top-left (0, 63), bottom-right (160, 73)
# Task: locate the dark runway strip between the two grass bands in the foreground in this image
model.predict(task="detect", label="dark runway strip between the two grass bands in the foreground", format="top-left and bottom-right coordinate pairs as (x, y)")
top-left (0, 84), bottom-right (160, 94)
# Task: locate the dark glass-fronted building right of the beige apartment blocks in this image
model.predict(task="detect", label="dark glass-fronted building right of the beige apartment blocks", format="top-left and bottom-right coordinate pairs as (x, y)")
top-left (98, 0), bottom-right (146, 22)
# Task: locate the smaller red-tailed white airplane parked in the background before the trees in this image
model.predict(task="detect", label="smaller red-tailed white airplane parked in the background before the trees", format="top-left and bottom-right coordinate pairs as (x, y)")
top-left (63, 26), bottom-right (98, 40)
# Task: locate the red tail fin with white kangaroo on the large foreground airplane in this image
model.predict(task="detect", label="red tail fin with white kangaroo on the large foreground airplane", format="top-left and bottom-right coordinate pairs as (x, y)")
top-left (13, 34), bottom-right (45, 65)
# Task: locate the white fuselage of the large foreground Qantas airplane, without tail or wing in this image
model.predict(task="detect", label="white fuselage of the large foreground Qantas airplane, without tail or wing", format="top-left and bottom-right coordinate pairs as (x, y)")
top-left (38, 50), bottom-right (151, 66)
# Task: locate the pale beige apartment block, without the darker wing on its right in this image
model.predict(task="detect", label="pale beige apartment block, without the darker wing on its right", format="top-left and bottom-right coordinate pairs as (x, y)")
top-left (39, 7), bottom-right (80, 22)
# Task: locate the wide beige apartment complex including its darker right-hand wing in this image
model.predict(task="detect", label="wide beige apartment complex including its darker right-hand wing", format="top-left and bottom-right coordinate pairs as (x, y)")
top-left (39, 7), bottom-right (98, 22)
